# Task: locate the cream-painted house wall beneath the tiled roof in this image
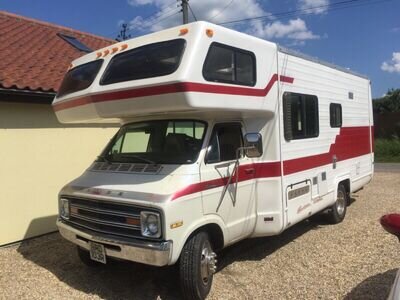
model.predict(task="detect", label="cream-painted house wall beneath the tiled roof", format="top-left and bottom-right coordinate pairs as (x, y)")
top-left (0, 102), bottom-right (118, 245)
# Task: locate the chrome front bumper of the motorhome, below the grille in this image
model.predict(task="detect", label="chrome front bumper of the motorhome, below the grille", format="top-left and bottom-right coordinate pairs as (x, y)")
top-left (57, 220), bottom-right (172, 266)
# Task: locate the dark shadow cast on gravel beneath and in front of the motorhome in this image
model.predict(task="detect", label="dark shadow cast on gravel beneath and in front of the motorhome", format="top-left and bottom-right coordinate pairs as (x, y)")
top-left (18, 217), bottom-right (328, 299)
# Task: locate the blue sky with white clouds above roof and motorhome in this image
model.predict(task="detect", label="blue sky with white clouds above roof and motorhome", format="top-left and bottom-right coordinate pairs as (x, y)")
top-left (0, 0), bottom-right (400, 97)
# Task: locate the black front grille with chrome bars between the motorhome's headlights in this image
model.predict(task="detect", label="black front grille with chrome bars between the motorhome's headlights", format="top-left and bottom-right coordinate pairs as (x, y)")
top-left (63, 197), bottom-right (161, 238)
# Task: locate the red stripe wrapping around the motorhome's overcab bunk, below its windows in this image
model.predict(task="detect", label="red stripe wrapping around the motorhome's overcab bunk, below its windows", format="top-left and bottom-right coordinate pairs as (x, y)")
top-left (53, 74), bottom-right (294, 111)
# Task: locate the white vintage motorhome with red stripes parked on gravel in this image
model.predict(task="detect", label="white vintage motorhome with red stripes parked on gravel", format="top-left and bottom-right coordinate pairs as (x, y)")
top-left (53, 22), bottom-right (374, 299)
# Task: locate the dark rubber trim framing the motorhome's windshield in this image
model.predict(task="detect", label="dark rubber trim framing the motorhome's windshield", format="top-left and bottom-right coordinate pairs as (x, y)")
top-left (100, 118), bottom-right (208, 165)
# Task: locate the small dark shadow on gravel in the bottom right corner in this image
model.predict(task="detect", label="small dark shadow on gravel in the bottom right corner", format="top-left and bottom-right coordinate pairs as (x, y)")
top-left (344, 269), bottom-right (397, 300)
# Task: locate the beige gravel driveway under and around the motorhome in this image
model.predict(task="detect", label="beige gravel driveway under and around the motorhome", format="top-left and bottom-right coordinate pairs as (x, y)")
top-left (0, 173), bottom-right (400, 300)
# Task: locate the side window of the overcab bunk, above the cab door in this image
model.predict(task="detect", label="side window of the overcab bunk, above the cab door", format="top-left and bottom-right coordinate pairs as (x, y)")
top-left (203, 43), bottom-right (256, 86)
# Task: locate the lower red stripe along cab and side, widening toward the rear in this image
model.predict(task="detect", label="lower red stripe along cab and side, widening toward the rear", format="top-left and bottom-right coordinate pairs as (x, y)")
top-left (171, 126), bottom-right (373, 200)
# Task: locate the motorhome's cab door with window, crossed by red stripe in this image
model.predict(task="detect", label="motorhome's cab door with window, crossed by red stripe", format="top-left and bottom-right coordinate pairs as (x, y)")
top-left (200, 122), bottom-right (256, 242)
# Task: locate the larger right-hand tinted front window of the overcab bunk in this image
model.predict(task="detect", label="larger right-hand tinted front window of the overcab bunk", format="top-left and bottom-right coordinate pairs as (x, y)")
top-left (100, 39), bottom-right (186, 85)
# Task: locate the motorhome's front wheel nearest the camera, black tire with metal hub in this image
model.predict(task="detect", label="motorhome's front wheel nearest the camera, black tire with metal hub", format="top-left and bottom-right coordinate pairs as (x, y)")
top-left (179, 232), bottom-right (217, 300)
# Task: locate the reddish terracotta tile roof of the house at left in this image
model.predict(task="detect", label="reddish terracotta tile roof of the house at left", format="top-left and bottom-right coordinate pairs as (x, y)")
top-left (0, 11), bottom-right (115, 92)
